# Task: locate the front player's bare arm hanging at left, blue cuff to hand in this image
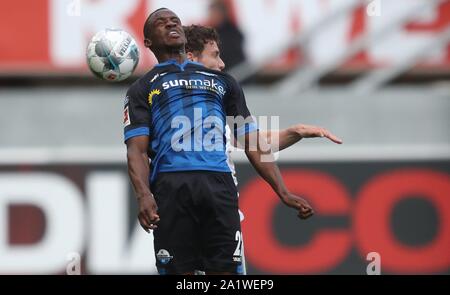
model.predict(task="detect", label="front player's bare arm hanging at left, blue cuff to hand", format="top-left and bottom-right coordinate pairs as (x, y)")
top-left (127, 136), bottom-right (159, 232)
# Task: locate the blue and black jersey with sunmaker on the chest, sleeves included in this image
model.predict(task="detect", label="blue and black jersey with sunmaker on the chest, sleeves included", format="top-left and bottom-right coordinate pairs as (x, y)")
top-left (124, 60), bottom-right (257, 181)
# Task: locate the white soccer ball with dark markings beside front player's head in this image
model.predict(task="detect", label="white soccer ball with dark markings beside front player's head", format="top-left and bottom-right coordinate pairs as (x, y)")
top-left (86, 29), bottom-right (139, 81)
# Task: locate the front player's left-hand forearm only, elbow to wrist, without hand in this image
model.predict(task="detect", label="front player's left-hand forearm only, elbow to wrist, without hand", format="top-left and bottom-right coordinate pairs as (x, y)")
top-left (127, 150), bottom-right (152, 199)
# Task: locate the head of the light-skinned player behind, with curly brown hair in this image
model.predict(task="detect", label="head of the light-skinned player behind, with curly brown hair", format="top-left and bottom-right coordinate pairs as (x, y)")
top-left (183, 25), bottom-right (225, 71)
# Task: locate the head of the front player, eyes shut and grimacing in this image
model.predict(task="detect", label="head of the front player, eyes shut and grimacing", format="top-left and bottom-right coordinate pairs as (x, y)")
top-left (144, 8), bottom-right (186, 54)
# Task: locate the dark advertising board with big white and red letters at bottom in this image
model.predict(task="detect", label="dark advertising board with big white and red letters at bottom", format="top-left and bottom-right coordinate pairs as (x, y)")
top-left (0, 159), bottom-right (450, 274)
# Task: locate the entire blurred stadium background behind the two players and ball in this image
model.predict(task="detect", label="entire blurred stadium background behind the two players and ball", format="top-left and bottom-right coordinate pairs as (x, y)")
top-left (0, 0), bottom-right (450, 274)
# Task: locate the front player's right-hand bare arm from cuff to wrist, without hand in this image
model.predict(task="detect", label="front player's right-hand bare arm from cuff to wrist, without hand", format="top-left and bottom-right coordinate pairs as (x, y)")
top-left (245, 136), bottom-right (289, 199)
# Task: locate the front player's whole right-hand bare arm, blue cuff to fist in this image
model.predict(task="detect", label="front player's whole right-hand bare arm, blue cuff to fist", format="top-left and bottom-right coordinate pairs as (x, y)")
top-left (241, 131), bottom-right (314, 219)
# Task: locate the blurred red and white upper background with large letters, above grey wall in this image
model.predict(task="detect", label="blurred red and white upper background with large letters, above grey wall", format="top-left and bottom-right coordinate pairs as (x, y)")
top-left (0, 0), bottom-right (450, 88)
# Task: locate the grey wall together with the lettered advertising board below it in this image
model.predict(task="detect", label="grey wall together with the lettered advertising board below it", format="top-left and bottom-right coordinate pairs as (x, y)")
top-left (0, 87), bottom-right (450, 274)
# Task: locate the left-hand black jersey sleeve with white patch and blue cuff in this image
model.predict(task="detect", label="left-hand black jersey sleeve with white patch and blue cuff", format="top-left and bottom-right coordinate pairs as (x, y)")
top-left (123, 82), bottom-right (151, 142)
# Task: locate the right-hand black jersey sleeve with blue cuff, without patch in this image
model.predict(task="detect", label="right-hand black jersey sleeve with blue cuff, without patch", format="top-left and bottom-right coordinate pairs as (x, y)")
top-left (224, 76), bottom-right (258, 137)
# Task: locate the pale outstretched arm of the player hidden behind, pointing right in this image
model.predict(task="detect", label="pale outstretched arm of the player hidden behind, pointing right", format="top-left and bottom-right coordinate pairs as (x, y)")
top-left (260, 124), bottom-right (342, 152)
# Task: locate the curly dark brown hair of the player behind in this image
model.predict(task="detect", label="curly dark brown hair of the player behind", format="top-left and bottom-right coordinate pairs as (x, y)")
top-left (183, 25), bottom-right (220, 53)
